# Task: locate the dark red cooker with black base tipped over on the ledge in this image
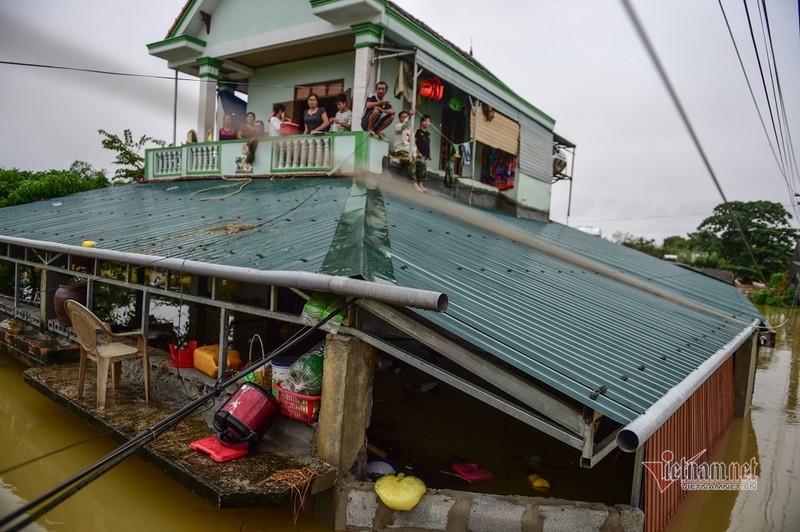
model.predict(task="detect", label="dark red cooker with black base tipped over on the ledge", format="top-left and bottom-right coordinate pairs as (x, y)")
top-left (214, 382), bottom-right (280, 449)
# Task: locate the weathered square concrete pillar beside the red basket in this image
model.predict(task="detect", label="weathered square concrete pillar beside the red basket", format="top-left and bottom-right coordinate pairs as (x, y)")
top-left (317, 334), bottom-right (374, 474)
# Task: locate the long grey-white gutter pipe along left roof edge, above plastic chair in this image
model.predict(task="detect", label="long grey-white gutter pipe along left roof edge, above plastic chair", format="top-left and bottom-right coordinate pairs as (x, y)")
top-left (0, 236), bottom-right (448, 312)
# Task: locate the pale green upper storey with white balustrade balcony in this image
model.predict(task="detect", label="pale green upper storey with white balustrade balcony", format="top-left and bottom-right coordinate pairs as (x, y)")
top-left (147, 0), bottom-right (574, 220)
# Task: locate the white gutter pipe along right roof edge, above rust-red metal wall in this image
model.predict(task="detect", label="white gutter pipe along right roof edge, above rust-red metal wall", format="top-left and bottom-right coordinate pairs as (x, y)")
top-left (617, 320), bottom-right (759, 453)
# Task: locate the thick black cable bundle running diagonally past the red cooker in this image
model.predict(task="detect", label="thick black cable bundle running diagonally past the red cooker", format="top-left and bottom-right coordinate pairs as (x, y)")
top-left (0, 298), bottom-right (357, 532)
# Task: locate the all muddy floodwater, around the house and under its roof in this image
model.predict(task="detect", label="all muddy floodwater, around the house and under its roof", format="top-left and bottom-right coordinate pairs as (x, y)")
top-left (0, 302), bottom-right (800, 532)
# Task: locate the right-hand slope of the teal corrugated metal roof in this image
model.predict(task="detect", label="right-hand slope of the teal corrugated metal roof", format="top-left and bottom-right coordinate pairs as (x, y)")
top-left (387, 199), bottom-right (760, 423)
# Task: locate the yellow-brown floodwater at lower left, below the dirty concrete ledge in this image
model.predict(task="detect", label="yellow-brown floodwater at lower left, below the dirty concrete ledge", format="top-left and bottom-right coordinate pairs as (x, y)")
top-left (0, 355), bottom-right (332, 532)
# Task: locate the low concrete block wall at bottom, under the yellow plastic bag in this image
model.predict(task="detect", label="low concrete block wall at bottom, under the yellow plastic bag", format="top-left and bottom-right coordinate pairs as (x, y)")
top-left (335, 480), bottom-right (644, 532)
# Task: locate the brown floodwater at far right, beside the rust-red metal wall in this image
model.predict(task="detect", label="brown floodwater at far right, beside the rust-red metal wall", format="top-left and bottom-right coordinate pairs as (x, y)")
top-left (668, 307), bottom-right (800, 532)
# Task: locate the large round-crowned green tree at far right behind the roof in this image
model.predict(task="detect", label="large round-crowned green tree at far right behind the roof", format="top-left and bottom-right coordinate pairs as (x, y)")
top-left (691, 200), bottom-right (800, 282)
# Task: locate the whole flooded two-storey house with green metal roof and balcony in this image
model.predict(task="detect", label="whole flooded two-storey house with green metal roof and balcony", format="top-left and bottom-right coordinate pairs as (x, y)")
top-left (0, 0), bottom-right (767, 530)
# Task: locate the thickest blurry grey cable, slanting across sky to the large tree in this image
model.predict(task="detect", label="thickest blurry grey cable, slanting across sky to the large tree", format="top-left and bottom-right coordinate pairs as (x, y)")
top-left (620, 0), bottom-right (769, 286)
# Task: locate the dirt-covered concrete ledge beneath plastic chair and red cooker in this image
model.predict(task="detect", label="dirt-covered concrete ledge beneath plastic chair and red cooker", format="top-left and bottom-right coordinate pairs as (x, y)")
top-left (24, 357), bottom-right (336, 508)
